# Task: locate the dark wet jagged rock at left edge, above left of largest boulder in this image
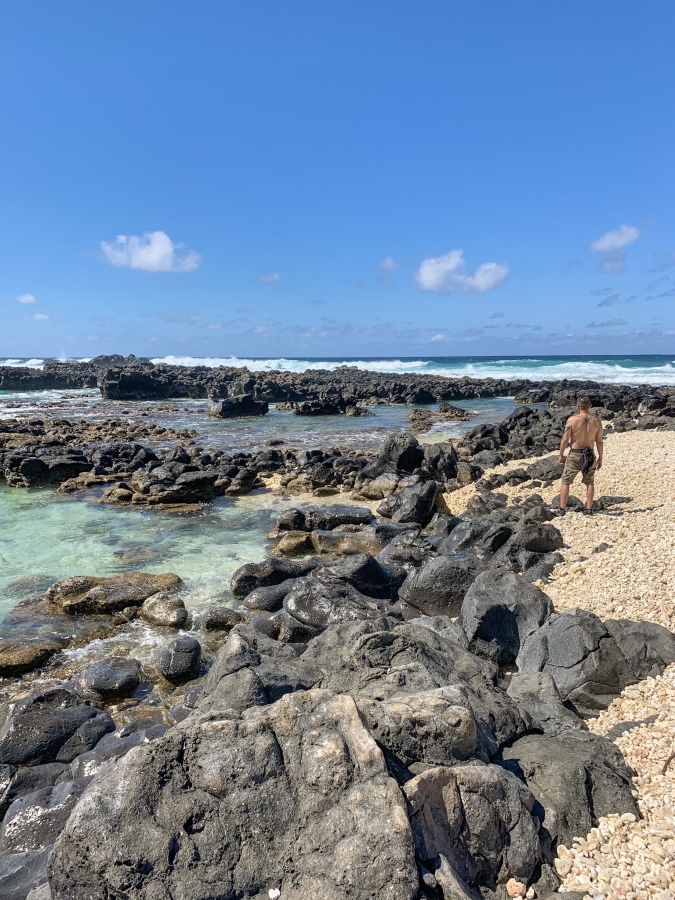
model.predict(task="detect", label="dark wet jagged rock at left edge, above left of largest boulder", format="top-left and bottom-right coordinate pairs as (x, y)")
top-left (0, 688), bottom-right (115, 766)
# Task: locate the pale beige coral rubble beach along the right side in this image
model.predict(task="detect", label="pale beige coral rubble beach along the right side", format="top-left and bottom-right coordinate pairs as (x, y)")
top-left (446, 431), bottom-right (675, 900)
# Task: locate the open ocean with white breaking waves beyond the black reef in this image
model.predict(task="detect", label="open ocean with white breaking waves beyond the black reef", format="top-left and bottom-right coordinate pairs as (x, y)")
top-left (0, 353), bottom-right (675, 385)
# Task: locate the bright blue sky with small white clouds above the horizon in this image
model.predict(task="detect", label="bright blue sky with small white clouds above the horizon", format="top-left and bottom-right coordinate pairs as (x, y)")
top-left (0, 0), bottom-right (675, 357)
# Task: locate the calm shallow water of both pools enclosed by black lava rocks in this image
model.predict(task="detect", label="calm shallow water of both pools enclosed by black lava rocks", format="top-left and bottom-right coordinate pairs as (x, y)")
top-left (0, 390), bottom-right (524, 616)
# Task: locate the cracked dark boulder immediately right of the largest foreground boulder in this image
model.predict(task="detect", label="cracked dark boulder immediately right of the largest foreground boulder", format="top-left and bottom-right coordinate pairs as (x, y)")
top-left (403, 765), bottom-right (541, 896)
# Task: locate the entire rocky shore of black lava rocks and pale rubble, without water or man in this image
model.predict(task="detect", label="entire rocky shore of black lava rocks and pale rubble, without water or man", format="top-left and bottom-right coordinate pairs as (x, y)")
top-left (0, 358), bottom-right (675, 900)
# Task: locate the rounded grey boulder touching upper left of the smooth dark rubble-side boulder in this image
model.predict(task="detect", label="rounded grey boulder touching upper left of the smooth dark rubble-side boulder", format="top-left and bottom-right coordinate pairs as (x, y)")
top-left (399, 555), bottom-right (484, 616)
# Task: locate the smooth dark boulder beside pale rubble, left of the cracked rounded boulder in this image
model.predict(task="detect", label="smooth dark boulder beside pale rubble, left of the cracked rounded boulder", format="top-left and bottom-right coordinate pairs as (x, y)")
top-left (459, 569), bottom-right (553, 664)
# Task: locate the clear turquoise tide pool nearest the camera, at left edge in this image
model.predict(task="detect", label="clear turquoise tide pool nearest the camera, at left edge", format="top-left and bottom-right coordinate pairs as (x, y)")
top-left (0, 484), bottom-right (300, 616)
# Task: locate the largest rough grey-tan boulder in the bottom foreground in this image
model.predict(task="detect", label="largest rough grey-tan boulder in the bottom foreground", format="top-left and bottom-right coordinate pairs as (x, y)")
top-left (49, 691), bottom-right (418, 900)
